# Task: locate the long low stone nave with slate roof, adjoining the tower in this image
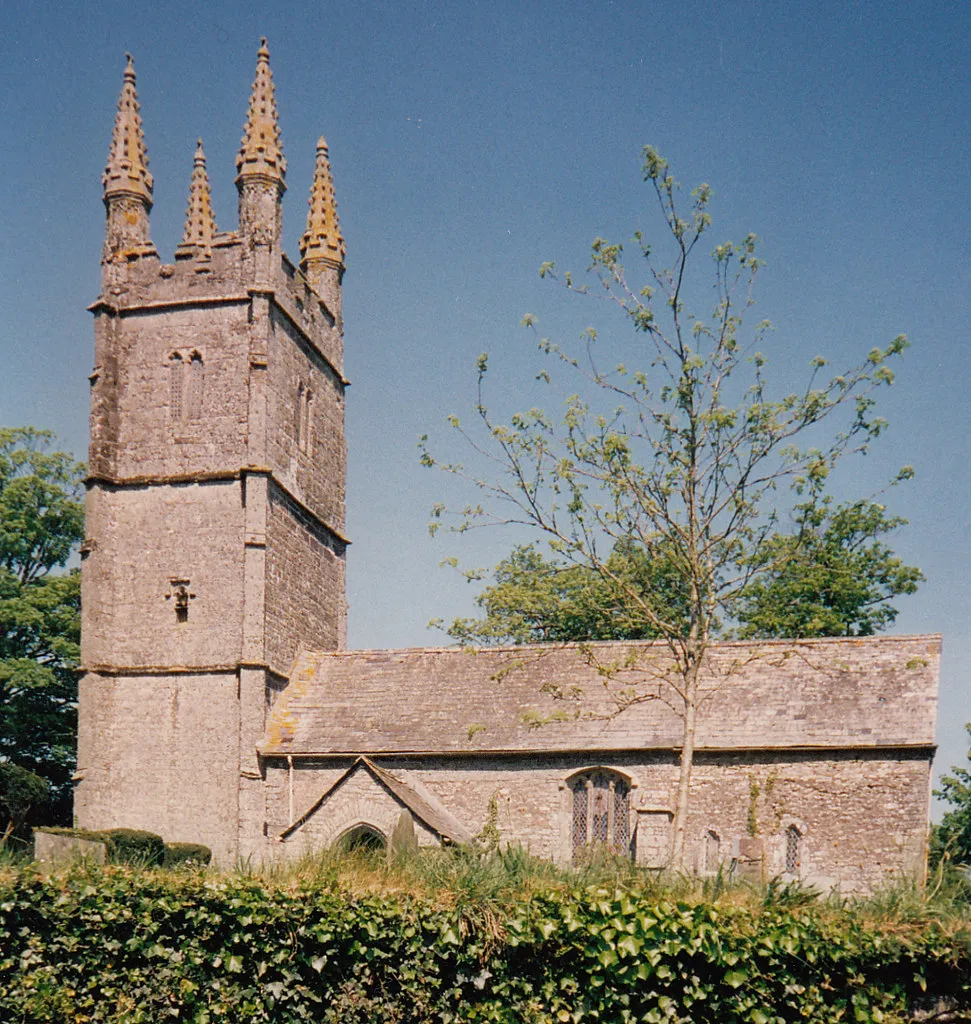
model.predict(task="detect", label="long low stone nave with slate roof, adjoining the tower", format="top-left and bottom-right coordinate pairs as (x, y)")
top-left (260, 636), bottom-right (940, 891)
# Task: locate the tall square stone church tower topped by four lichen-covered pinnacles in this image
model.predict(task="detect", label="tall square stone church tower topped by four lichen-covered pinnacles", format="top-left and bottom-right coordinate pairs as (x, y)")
top-left (75, 46), bottom-right (347, 862)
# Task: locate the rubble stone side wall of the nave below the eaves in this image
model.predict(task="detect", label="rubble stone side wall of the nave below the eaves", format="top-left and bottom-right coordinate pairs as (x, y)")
top-left (266, 751), bottom-right (930, 892)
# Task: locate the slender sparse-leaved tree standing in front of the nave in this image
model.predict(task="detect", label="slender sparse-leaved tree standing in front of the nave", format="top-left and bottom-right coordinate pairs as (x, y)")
top-left (422, 146), bottom-right (909, 868)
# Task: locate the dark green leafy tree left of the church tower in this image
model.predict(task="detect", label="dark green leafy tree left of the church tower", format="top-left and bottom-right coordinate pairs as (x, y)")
top-left (0, 427), bottom-right (84, 817)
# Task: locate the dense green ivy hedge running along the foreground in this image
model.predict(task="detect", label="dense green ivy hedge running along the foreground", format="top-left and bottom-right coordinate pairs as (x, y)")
top-left (0, 867), bottom-right (971, 1024)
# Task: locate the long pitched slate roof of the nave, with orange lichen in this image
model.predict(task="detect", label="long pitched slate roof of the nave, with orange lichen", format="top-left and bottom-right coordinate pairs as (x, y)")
top-left (260, 635), bottom-right (940, 756)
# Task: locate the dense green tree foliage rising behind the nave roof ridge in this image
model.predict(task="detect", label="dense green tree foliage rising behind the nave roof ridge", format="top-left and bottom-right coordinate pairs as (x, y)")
top-left (446, 501), bottom-right (924, 644)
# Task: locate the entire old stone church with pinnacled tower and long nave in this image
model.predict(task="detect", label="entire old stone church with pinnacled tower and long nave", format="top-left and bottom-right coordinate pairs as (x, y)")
top-left (75, 40), bottom-right (940, 892)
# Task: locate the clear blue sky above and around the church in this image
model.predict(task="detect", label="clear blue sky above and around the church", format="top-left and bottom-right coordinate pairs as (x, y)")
top-left (0, 0), bottom-right (971, 798)
